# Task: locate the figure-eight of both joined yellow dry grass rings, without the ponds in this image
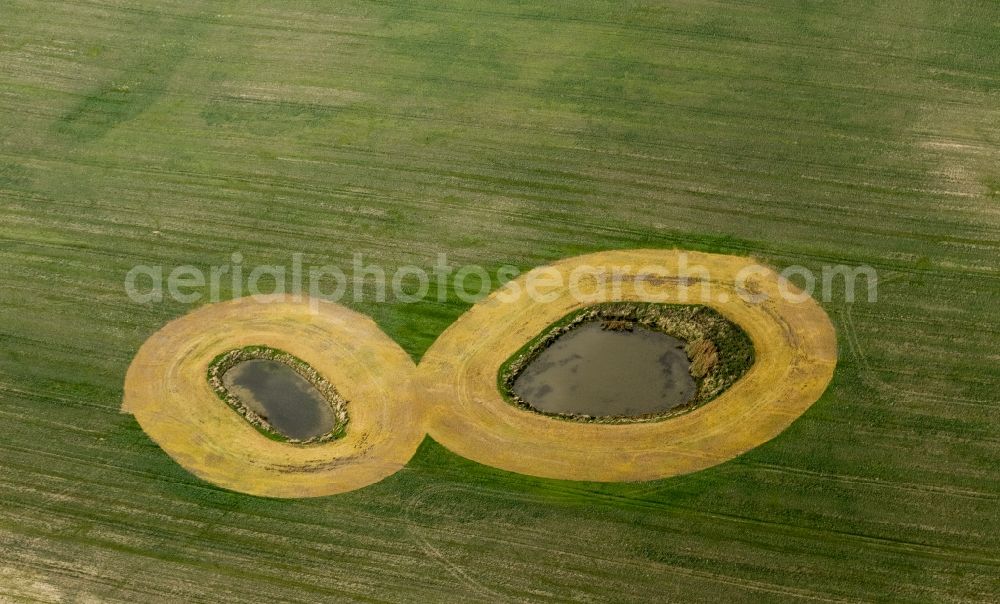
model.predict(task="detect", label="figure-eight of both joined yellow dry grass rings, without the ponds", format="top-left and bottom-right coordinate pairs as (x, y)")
top-left (123, 250), bottom-right (837, 497)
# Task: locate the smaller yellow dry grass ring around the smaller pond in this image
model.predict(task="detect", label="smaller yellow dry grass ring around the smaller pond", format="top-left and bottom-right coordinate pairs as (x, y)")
top-left (123, 296), bottom-right (426, 497)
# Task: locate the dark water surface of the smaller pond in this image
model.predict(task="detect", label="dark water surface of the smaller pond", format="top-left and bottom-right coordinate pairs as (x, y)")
top-left (222, 359), bottom-right (335, 440)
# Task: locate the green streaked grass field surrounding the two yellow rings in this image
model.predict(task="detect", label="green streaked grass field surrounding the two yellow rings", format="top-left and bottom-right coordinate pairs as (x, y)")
top-left (0, 0), bottom-right (1000, 602)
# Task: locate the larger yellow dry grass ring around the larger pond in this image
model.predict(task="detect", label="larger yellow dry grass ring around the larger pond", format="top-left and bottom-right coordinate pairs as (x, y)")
top-left (417, 250), bottom-right (837, 481)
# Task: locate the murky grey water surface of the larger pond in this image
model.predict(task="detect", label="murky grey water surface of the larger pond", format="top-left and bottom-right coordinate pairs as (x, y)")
top-left (512, 321), bottom-right (697, 416)
